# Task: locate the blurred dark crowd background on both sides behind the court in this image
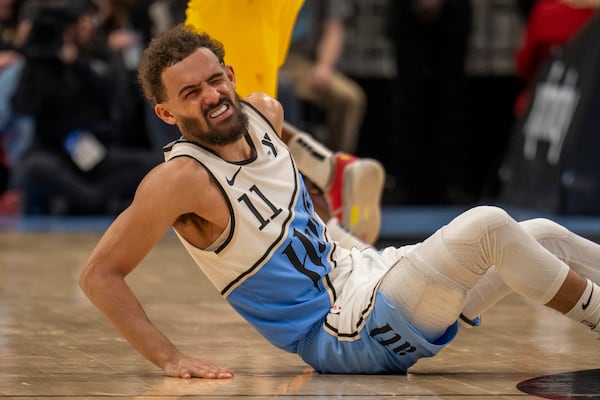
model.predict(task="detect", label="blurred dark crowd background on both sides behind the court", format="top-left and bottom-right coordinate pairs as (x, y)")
top-left (0, 0), bottom-right (600, 215)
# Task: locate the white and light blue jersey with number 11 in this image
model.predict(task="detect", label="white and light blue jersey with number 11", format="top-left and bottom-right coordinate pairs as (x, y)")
top-left (165, 102), bottom-right (397, 352)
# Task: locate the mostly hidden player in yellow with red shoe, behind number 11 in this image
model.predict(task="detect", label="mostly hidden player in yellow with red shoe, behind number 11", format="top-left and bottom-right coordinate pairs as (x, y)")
top-left (185, 0), bottom-right (385, 244)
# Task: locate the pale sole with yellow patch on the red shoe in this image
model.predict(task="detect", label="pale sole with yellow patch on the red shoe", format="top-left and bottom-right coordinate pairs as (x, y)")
top-left (341, 158), bottom-right (385, 244)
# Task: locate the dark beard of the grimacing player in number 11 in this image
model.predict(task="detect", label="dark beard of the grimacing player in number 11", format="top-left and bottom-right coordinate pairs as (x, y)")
top-left (179, 96), bottom-right (248, 146)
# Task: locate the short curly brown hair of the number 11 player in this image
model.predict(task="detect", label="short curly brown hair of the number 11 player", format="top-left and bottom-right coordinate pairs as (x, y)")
top-left (138, 24), bottom-right (225, 105)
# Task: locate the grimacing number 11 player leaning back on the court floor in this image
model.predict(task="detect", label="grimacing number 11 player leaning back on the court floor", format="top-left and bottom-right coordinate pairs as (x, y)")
top-left (80, 26), bottom-right (600, 378)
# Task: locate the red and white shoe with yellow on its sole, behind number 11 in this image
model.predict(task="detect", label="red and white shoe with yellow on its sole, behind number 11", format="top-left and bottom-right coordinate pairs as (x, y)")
top-left (326, 153), bottom-right (385, 244)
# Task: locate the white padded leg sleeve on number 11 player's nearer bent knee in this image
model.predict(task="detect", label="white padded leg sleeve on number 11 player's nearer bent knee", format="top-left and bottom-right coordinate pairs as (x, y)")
top-left (381, 207), bottom-right (569, 340)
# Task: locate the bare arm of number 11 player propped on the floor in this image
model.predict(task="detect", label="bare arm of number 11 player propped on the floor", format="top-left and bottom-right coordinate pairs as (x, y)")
top-left (79, 162), bottom-right (233, 378)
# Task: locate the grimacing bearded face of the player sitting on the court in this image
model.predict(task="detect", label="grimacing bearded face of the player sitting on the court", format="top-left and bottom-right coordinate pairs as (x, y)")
top-left (155, 48), bottom-right (248, 146)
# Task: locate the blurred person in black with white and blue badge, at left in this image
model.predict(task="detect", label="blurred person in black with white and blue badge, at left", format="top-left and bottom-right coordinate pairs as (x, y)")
top-left (12, 0), bottom-right (161, 214)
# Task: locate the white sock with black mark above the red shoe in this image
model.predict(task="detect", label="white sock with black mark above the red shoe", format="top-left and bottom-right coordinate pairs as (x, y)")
top-left (287, 132), bottom-right (333, 191)
